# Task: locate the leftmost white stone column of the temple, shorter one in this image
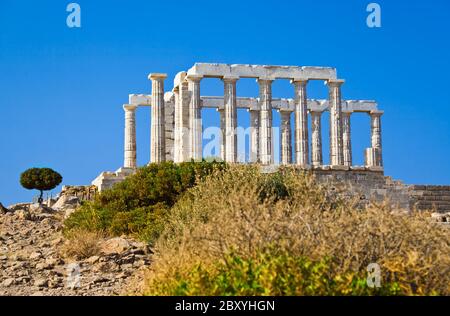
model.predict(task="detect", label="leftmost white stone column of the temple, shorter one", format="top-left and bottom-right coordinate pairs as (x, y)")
top-left (123, 104), bottom-right (137, 169)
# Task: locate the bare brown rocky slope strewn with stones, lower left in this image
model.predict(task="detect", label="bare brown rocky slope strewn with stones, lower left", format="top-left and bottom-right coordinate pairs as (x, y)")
top-left (0, 202), bottom-right (150, 296)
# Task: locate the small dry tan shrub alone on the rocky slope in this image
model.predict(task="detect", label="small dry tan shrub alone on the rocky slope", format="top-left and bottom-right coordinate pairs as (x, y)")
top-left (61, 229), bottom-right (105, 260)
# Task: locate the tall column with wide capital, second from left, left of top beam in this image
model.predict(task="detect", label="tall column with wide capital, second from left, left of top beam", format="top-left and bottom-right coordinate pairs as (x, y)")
top-left (149, 73), bottom-right (167, 163)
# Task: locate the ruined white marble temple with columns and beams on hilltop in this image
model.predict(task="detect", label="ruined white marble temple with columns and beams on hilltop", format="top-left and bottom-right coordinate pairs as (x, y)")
top-left (93, 63), bottom-right (383, 190)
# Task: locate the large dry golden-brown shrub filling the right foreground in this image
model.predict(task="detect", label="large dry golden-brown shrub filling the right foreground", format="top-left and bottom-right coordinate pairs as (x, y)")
top-left (146, 166), bottom-right (450, 295)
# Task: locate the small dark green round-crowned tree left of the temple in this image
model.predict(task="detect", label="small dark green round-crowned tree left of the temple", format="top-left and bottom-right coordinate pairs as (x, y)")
top-left (20, 168), bottom-right (62, 204)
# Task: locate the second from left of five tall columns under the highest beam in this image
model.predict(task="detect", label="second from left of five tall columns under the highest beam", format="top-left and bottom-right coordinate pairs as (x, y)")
top-left (223, 77), bottom-right (239, 163)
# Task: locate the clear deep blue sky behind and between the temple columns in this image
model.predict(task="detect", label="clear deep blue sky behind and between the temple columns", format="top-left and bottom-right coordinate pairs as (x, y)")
top-left (0, 0), bottom-right (450, 205)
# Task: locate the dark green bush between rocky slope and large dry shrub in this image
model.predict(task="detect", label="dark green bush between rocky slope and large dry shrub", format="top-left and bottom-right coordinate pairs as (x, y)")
top-left (65, 161), bottom-right (225, 241)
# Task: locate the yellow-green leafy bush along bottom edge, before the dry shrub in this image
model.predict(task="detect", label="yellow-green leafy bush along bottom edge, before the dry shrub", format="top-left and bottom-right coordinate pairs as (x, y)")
top-left (146, 251), bottom-right (402, 296)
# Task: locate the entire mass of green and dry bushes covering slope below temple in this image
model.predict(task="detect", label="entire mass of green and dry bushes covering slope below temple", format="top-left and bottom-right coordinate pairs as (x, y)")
top-left (67, 163), bottom-right (450, 295)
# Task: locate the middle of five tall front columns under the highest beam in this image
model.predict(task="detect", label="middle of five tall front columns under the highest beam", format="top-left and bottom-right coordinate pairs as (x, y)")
top-left (257, 78), bottom-right (273, 165)
